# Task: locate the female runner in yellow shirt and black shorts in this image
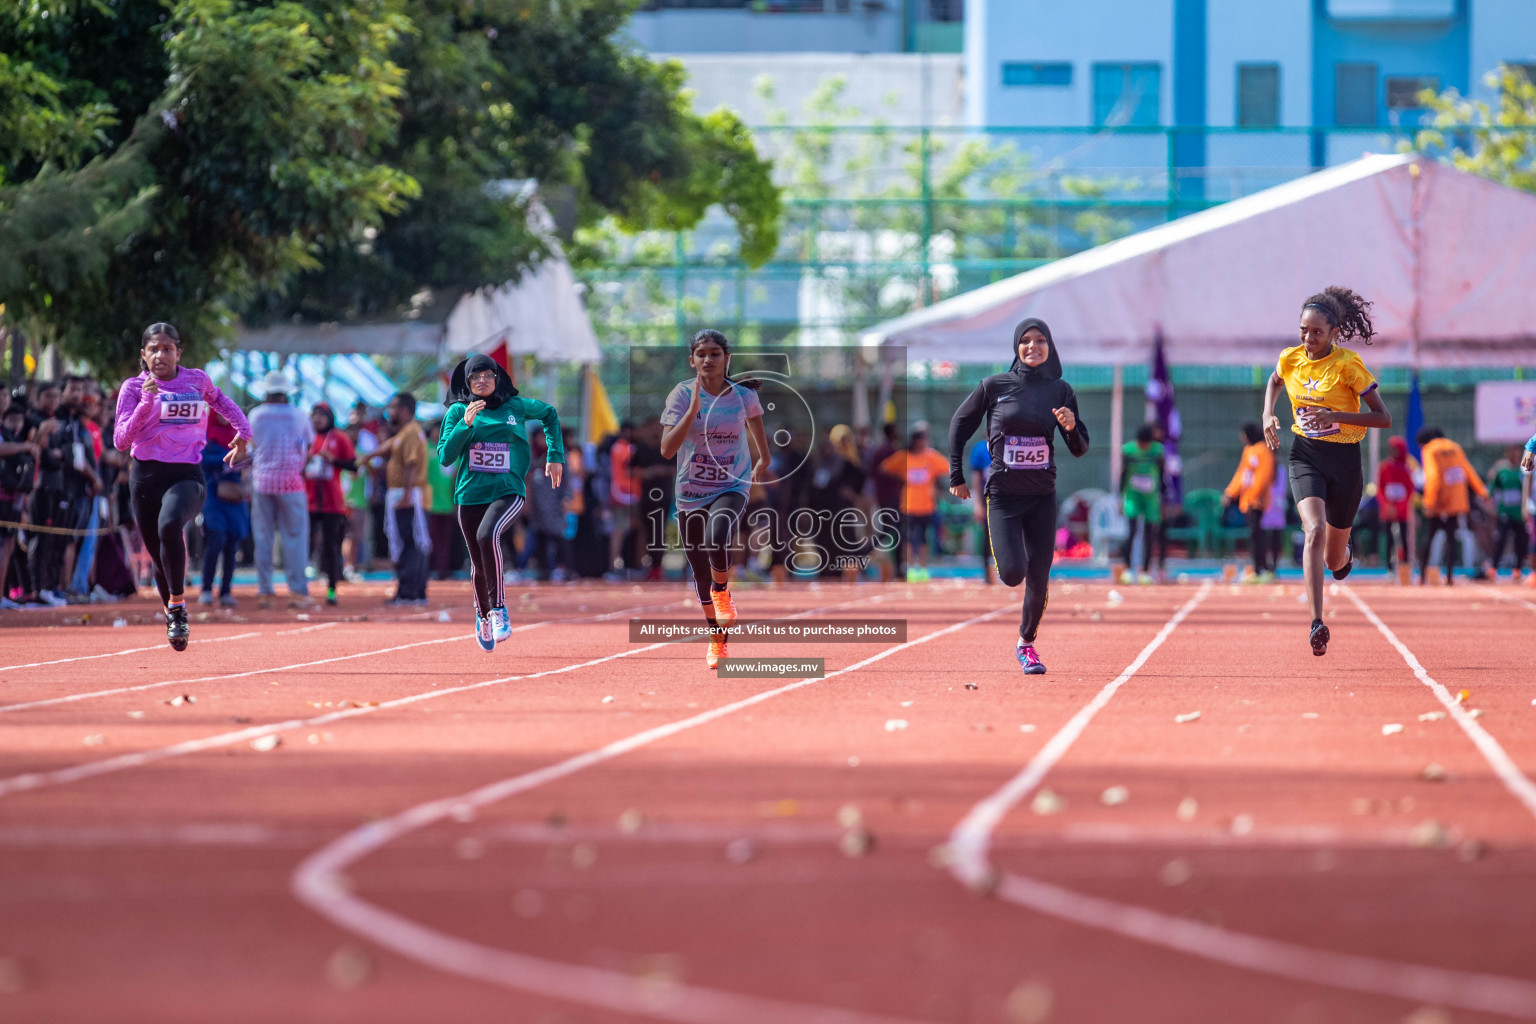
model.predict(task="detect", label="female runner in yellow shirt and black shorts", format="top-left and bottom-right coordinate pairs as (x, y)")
top-left (1264, 287), bottom-right (1392, 657)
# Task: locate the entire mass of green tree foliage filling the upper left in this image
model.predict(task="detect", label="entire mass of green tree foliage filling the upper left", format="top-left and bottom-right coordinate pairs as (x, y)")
top-left (0, 0), bottom-right (779, 370)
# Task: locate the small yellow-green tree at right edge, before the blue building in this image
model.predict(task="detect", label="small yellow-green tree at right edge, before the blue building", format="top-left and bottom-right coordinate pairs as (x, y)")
top-left (1413, 64), bottom-right (1536, 192)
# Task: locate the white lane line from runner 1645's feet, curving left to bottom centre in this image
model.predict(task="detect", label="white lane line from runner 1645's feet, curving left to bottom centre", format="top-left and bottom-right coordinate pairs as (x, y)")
top-left (290, 605), bottom-right (1012, 1024)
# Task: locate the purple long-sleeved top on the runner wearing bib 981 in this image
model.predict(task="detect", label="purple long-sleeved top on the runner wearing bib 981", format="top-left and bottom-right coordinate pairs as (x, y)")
top-left (112, 367), bottom-right (250, 464)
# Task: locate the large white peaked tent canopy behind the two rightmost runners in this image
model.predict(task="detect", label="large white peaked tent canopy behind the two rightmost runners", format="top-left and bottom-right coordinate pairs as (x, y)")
top-left (863, 155), bottom-right (1536, 367)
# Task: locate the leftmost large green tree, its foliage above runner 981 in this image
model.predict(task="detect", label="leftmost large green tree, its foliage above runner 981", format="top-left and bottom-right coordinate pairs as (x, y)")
top-left (0, 0), bottom-right (418, 372)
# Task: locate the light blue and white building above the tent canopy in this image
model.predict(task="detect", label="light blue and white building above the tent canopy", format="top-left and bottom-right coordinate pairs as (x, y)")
top-left (965, 0), bottom-right (1536, 166)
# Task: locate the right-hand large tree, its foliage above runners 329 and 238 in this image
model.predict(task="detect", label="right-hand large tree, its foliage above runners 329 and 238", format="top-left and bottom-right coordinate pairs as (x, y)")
top-left (253, 0), bottom-right (779, 319)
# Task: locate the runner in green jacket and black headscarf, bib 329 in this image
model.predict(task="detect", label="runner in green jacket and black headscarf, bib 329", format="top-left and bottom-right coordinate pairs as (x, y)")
top-left (438, 353), bottom-right (565, 651)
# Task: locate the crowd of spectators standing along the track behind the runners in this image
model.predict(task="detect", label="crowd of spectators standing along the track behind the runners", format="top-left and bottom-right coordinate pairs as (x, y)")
top-left (0, 372), bottom-right (1536, 609)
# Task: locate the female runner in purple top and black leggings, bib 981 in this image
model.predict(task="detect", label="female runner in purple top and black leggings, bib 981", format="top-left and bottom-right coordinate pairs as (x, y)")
top-left (112, 324), bottom-right (250, 651)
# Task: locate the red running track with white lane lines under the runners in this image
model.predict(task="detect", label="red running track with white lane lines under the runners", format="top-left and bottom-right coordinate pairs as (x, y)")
top-left (0, 583), bottom-right (1536, 1024)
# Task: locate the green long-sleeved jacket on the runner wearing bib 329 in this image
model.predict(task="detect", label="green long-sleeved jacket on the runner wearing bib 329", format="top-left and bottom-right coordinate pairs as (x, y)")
top-left (438, 395), bottom-right (565, 505)
